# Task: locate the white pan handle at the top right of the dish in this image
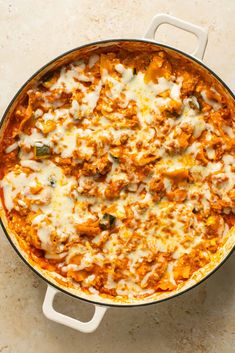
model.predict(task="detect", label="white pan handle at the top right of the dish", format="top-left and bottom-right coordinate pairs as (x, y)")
top-left (144, 14), bottom-right (208, 59)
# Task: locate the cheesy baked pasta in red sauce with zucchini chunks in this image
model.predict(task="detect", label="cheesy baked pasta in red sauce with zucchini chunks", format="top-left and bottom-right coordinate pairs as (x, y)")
top-left (0, 47), bottom-right (235, 300)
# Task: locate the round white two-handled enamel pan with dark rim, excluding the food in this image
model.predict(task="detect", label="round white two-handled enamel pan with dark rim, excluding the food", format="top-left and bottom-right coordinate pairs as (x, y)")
top-left (1, 15), bottom-right (234, 332)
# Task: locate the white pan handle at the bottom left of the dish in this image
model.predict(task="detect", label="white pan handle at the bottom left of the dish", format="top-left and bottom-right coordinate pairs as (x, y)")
top-left (42, 285), bottom-right (108, 333)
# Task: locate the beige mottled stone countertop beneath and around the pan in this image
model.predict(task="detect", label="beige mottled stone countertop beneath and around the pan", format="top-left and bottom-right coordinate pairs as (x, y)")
top-left (0, 0), bottom-right (235, 353)
